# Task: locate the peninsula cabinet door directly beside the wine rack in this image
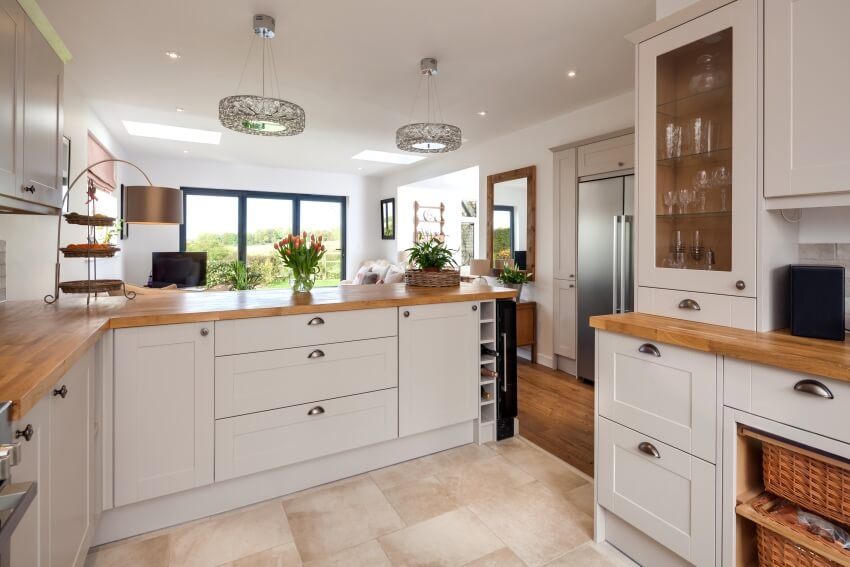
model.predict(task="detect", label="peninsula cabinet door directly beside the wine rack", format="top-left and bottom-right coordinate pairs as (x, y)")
top-left (398, 302), bottom-right (480, 437)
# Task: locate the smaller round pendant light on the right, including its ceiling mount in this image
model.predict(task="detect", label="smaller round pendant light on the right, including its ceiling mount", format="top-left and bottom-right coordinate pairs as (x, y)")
top-left (395, 57), bottom-right (461, 154)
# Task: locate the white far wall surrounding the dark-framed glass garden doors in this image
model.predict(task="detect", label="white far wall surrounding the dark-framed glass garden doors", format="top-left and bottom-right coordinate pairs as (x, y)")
top-left (121, 157), bottom-right (383, 285)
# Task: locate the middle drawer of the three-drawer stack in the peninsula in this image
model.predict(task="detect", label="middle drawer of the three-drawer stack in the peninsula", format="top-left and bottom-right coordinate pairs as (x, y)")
top-left (215, 337), bottom-right (398, 419)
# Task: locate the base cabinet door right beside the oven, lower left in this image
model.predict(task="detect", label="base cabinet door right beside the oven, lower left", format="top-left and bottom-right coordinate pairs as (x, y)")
top-left (10, 396), bottom-right (51, 567)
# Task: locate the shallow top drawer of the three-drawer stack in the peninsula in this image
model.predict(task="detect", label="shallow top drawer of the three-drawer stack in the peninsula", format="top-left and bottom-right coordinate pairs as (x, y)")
top-left (215, 307), bottom-right (398, 356)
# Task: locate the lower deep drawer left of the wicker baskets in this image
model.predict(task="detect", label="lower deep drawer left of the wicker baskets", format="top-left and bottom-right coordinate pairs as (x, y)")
top-left (597, 418), bottom-right (717, 566)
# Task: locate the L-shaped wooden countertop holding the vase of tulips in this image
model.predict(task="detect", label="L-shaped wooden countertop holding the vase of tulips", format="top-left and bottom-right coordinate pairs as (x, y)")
top-left (0, 284), bottom-right (516, 420)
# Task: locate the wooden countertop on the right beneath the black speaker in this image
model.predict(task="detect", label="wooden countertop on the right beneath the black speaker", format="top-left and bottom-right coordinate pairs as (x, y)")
top-left (590, 313), bottom-right (850, 382)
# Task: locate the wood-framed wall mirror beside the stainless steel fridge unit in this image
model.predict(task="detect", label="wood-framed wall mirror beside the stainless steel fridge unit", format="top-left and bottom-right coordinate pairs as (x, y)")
top-left (487, 165), bottom-right (537, 279)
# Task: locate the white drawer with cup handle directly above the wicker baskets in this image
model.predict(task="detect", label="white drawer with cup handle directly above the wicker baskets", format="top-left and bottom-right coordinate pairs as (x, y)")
top-left (723, 358), bottom-right (850, 443)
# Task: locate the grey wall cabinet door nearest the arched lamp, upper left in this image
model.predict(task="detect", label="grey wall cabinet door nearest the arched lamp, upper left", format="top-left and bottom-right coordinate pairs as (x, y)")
top-left (18, 16), bottom-right (63, 208)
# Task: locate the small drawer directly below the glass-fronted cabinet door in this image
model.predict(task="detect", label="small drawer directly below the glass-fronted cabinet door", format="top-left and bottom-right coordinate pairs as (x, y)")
top-left (637, 287), bottom-right (756, 331)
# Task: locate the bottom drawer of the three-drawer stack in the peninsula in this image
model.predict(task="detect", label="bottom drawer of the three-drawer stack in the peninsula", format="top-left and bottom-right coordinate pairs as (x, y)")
top-left (215, 388), bottom-right (398, 482)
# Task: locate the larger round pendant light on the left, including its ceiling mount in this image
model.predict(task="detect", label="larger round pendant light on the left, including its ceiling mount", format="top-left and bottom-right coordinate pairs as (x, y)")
top-left (218, 14), bottom-right (305, 136)
